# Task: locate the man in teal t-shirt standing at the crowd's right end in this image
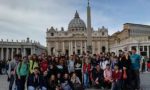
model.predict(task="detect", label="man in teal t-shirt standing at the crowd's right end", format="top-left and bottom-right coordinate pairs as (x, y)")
top-left (130, 48), bottom-right (141, 90)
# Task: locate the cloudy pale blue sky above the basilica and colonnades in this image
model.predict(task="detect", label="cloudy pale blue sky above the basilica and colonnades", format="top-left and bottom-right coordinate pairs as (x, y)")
top-left (0, 0), bottom-right (150, 46)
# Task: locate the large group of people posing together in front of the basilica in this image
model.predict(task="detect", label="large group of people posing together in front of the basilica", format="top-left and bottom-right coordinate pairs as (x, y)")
top-left (8, 48), bottom-right (141, 90)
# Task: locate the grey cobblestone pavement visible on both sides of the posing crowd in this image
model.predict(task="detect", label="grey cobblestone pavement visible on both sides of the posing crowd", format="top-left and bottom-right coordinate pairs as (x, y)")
top-left (0, 73), bottom-right (150, 90)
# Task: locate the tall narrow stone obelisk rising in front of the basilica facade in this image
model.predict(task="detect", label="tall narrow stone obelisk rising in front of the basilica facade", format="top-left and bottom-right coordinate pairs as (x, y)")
top-left (87, 0), bottom-right (92, 54)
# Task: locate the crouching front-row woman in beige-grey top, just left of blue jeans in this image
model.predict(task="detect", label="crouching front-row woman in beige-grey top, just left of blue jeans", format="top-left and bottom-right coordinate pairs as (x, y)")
top-left (71, 73), bottom-right (82, 90)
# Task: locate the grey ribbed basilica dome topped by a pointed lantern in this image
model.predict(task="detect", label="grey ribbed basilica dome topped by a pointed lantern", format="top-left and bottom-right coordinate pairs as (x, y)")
top-left (68, 11), bottom-right (86, 31)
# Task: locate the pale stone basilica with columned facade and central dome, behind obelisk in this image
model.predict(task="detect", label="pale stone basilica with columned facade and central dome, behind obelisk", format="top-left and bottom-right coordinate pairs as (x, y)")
top-left (46, 11), bottom-right (109, 55)
